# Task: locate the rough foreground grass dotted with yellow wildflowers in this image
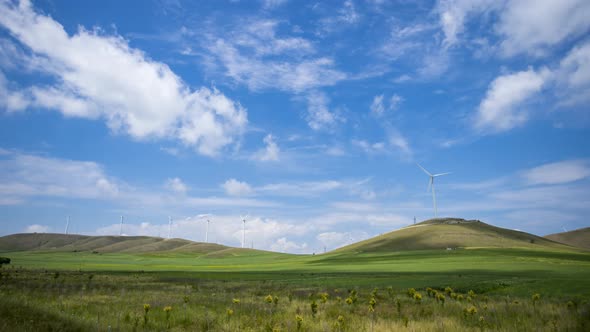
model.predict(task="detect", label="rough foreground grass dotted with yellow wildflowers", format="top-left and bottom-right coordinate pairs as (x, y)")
top-left (0, 268), bottom-right (590, 331)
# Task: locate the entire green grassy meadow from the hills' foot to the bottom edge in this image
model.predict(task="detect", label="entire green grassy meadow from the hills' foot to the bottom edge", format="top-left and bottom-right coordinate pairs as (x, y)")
top-left (0, 248), bottom-right (590, 331)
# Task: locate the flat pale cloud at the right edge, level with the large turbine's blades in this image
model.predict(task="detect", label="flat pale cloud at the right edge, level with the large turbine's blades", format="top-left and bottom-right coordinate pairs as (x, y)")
top-left (522, 160), bottom-right (590, 185)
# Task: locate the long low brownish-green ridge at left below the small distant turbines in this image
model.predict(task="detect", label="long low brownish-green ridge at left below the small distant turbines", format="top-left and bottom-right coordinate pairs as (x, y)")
top-left (0, 233), bottom-right (229, 255)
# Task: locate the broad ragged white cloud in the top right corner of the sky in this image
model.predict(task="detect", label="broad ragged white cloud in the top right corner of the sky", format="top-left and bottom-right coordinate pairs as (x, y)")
top-left (436, 0), bottom-right (590, 56)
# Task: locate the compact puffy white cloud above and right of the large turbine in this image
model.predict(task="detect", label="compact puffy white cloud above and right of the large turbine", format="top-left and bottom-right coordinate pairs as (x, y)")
top-left (474, 68), bottom-right (551, 132)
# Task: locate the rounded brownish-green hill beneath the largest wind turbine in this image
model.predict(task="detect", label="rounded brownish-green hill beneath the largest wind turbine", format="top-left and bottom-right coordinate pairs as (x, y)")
top-left (333, 218), bottom-right (572, 252)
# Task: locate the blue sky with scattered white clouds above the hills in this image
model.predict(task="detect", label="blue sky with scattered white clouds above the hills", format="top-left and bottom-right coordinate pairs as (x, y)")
top-left (0, 0), bottom-right (590, 253)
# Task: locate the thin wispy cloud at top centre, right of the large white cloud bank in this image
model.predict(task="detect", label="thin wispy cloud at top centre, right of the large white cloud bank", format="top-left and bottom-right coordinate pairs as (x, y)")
top-left (204, 20), bottom-right (346, 93)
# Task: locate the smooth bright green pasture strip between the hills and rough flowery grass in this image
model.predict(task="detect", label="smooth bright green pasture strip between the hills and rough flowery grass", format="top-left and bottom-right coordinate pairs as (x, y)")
top-left (0, 248), bottom-right (590, 297)
